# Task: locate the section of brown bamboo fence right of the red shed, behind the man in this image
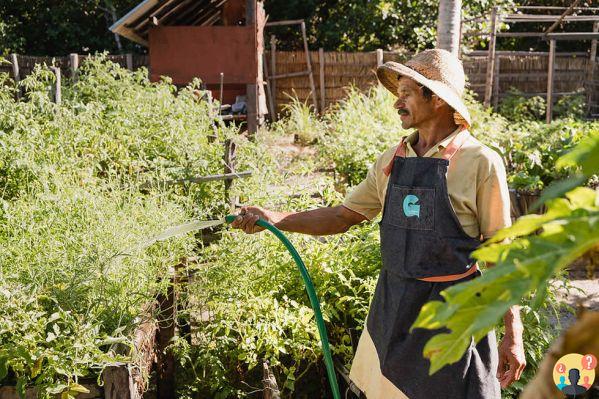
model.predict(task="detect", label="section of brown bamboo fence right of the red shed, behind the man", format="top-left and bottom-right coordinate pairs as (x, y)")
top-left (267, 51), bottom-right (599, 111)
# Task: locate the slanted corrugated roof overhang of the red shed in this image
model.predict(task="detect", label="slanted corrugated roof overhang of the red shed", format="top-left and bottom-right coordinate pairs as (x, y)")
top-left (110, 0), bottom-right (227, 46)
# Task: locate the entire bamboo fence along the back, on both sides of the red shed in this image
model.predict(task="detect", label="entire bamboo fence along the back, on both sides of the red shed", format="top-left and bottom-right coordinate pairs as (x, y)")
top-left (0, 50), bottom-right (599, 115)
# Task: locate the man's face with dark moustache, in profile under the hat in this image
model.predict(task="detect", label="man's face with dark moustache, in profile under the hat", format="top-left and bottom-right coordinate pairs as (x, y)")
top-left (394, 77), bottom-right (435, 129)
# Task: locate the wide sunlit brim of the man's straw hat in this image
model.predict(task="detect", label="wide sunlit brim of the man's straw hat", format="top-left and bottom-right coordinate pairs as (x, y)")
top-left (376, 61), bottom-right (472, 128)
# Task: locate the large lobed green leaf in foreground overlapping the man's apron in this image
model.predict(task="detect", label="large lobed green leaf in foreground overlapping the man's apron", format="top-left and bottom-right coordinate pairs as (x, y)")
top-left (412, 188), bottom-right (599, 374)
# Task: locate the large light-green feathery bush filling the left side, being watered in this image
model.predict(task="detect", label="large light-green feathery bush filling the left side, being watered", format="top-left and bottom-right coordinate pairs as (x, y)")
top-left (0, 56), bottom-right (238, 397)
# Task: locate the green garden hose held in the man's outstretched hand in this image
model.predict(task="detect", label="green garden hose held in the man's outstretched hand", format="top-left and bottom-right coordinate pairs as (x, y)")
top-left (225, 215), bottom-right (341, 399)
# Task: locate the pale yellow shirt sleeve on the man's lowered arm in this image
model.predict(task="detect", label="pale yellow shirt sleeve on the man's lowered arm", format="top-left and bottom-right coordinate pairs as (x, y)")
top-left (476, 152), bottom-right (512, 240)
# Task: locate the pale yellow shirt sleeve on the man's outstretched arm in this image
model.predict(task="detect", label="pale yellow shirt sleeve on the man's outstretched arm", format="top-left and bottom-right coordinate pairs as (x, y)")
top-left (343, 160), bottom-right (382, 220)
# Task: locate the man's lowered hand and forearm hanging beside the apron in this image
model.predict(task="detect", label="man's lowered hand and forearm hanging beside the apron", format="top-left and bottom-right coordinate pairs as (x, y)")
top-left (497, 307), bottom-right (526, 388)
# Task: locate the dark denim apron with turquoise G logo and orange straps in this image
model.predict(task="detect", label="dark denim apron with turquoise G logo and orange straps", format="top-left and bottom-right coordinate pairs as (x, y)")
top-left (366, 131), bottom-right (500, 399)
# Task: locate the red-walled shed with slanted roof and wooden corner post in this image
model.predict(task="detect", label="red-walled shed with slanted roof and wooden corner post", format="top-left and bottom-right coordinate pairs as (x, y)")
top-left (110, 0), bottom-right (267, 132)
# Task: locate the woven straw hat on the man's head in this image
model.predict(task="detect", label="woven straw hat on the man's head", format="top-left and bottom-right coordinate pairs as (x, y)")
top-left (376, 49), bottom-right (471, 128)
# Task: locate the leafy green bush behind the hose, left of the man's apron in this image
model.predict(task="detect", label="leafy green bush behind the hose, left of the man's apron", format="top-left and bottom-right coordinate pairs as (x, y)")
top-left (174, 212), bottom-right (380, 398)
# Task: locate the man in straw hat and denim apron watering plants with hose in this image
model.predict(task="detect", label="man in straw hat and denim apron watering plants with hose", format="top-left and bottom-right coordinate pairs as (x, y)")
top-left (233, 50), bottom-right (525, 399)
